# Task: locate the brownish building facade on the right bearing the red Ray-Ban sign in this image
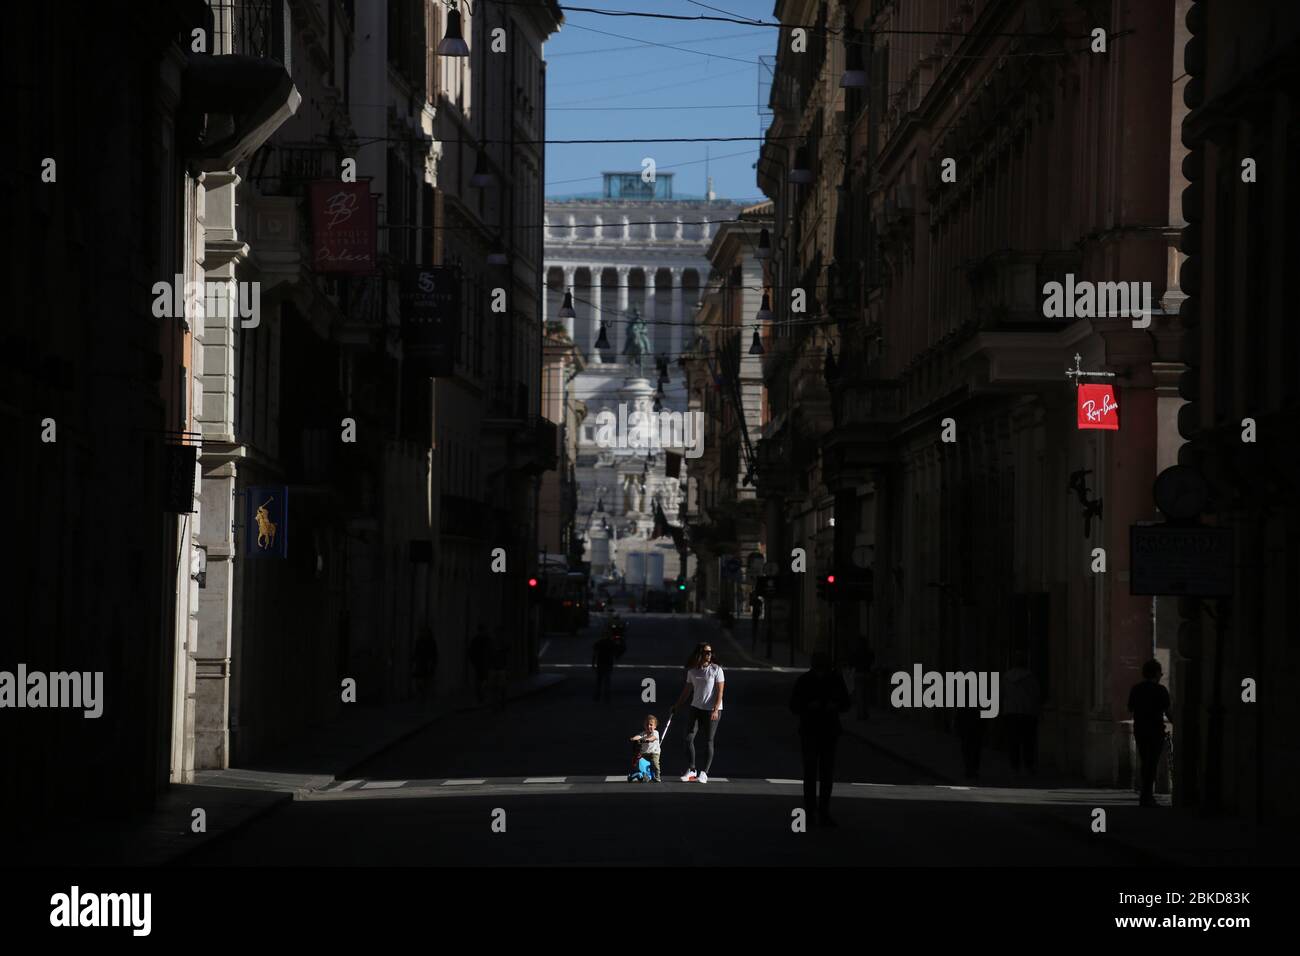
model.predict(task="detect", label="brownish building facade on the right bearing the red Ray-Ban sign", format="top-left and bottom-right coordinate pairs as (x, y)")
top-left (759, 0), bottom-right (1183, 783)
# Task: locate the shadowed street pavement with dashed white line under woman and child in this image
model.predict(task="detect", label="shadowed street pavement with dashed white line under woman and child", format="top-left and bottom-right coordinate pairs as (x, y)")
top-left (187, 615), bottom-right (1159, 866)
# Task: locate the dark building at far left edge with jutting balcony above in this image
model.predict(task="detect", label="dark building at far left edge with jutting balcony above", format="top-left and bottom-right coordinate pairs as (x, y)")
top-left (0, 3), bottom-right (300, 819)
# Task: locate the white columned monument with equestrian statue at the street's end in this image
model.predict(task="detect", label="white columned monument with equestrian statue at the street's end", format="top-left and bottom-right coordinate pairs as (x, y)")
top-left (543, 173), bottom-right (742, 592)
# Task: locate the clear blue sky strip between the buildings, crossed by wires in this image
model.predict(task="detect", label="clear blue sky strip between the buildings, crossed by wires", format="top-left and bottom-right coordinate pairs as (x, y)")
top-left (546, 0), bottom-right (777, 199)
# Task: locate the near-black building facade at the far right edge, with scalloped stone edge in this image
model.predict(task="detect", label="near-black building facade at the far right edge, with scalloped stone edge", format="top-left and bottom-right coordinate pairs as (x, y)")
top-left (1174, 3), bottom-right (1300, 829)
